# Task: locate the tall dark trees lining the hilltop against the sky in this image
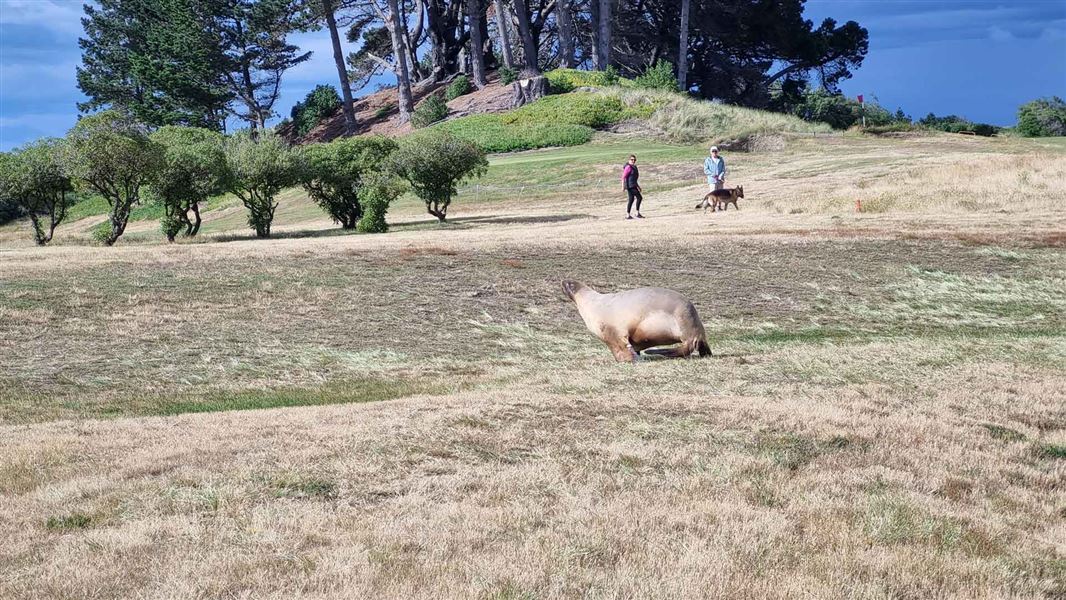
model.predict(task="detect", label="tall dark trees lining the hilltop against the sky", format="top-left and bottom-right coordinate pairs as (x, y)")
top-left (78, 0), bottom-right (868, 133)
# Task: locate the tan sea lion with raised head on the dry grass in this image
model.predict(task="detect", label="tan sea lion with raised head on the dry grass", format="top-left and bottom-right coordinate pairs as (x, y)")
top-left (563, 280), bottom-right (711, 361)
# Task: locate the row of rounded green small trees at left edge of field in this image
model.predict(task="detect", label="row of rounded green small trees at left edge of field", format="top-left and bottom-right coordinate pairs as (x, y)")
top-left (0, 111), bottom-right (488, 245)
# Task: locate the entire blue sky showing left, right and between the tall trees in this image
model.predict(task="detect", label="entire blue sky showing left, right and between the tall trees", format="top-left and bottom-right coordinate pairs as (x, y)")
top-left (0, 0), bottom-right (1066, 150)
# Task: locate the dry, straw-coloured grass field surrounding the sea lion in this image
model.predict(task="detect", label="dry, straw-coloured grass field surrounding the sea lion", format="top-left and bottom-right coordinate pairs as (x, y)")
top-left (0, 135), bottom-right (1066, 599)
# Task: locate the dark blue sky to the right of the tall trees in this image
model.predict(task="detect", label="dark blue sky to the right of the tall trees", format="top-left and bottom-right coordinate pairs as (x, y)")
top-left (805, 0), bottom-right (1066, 125)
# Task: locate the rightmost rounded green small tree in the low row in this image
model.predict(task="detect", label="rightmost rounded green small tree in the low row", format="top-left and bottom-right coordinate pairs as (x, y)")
top-left (391, 130), bottom-right (488, 222)
